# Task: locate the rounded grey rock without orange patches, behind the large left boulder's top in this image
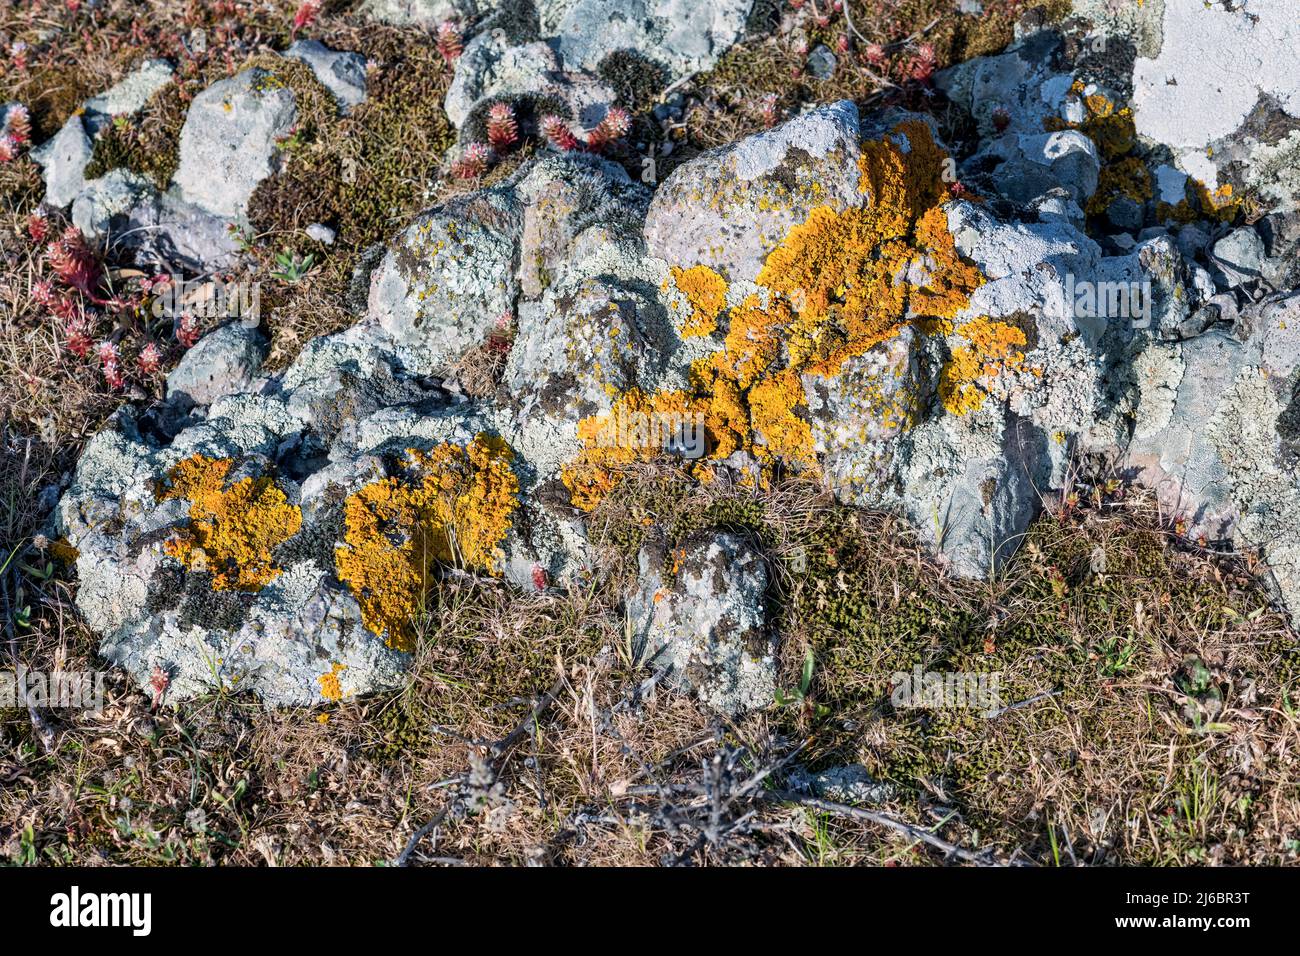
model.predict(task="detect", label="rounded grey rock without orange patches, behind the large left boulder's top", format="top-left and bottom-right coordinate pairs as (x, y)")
top-left (367, 190), bottom-right (523, 372)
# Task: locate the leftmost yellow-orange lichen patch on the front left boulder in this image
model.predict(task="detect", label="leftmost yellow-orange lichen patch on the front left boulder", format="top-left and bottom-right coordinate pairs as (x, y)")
top-left (157, 455), bottom-right (303, 591)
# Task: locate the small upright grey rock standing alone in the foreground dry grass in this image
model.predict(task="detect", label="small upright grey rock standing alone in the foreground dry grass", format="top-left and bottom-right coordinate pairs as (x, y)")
top-left (628, 532), bottom-right (776, 715)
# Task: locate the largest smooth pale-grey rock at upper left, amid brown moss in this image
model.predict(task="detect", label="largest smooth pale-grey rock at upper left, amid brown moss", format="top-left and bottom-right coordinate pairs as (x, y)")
top-left (173, 68), bottom-right (298, 220)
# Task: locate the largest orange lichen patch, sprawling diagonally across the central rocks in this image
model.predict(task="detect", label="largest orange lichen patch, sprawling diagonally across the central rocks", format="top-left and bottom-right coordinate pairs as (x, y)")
top-left (564, 121), bottom-right (984, 510)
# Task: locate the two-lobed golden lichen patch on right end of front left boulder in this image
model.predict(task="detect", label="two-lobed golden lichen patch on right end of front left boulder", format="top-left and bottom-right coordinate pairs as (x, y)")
top-left (334, 434), bottom-right (519, 650)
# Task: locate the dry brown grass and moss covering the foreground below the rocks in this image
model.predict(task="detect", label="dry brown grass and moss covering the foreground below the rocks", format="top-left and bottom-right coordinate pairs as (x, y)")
top-left (0, 450), bottom-right (1300, 865)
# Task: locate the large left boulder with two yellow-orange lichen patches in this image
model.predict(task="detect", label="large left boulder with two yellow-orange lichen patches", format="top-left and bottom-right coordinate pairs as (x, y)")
top-left (56, 326), bottom-right (519, 705)
